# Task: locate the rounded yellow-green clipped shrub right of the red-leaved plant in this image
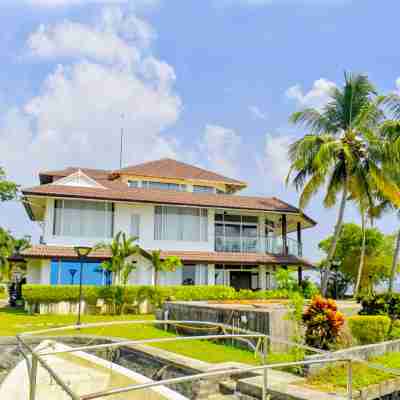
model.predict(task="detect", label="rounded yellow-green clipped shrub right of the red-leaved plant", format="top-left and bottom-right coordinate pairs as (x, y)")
top-left (347, 315), bottom-right (391, 345)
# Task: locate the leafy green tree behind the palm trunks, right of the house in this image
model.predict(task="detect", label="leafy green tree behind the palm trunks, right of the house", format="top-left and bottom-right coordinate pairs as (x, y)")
top-left (319, 223), bottom-right (395, 291)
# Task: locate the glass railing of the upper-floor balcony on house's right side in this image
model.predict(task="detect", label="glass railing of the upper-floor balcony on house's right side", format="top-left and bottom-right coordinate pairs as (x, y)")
top-left (215, 236), bottom-right (302, 257)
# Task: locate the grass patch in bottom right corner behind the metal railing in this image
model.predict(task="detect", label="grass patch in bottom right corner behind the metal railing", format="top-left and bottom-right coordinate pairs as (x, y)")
top-left (307, 353), bottom-right (400, 391)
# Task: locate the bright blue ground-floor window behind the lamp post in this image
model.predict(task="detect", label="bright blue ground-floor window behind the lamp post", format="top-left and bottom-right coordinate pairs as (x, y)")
top-left (50, 260), bottom-right (112, 286)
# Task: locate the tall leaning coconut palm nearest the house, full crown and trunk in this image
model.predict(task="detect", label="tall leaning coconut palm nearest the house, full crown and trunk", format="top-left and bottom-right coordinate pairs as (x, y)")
top-left (287, 74), bottom-right (400, 294)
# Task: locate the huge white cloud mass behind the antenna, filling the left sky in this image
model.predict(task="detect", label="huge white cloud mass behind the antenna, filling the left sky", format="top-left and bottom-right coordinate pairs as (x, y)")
top-left (0, 6), bottom-right (181, 184)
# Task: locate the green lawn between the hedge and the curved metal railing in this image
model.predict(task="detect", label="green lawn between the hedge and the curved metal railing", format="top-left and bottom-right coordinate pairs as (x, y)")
top-left (0, 308), bottom-right (266, 365)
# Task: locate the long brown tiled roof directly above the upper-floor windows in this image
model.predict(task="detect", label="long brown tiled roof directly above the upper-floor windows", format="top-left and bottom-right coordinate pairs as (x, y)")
top-left (22, 181), bottom-right (316, 225)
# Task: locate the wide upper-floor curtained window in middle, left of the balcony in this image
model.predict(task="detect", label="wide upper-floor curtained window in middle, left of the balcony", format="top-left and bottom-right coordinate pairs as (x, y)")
top-left (154, 206), bottom-right (208, 242)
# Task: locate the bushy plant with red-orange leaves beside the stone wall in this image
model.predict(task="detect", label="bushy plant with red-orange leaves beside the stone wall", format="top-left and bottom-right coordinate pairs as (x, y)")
top-left (303, 296), bottom-right (344, 350)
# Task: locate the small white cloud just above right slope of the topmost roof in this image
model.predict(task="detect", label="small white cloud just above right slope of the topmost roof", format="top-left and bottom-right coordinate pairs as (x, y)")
top-left (200, 124), bottom-right (242, 178)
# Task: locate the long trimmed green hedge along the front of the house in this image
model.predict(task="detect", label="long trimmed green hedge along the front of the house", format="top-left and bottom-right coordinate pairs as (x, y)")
top-left (22, 285), bottom-right (289, 304)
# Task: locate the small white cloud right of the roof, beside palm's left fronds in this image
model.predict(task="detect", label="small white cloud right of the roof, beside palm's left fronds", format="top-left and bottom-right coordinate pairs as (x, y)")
top-left (257, 133), bottom-right (295, 183)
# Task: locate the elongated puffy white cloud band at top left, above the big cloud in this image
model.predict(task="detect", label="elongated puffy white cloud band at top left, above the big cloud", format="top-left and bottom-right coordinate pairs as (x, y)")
top-left (28, 7), bottom-right (155, 68)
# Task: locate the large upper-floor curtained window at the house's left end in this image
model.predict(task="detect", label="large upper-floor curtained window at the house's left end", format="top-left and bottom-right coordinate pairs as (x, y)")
top-left (53, 200), bottom-right (114, 239)
